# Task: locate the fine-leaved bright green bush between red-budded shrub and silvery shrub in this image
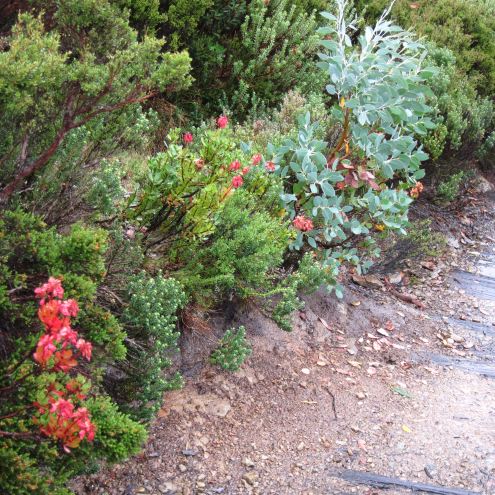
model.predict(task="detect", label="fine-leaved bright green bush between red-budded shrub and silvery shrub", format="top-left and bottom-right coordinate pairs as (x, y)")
top-left (177, 190), bottom-right (289, 306)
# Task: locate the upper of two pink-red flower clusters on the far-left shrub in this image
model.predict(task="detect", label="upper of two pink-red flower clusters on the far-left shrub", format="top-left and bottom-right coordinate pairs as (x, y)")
top-left (34, 277), bottom-right (92, 372)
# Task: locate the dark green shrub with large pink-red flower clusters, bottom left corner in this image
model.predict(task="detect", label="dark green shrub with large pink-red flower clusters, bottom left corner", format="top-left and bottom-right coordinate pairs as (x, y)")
top-left (0, 215), bottom-right (145, 495)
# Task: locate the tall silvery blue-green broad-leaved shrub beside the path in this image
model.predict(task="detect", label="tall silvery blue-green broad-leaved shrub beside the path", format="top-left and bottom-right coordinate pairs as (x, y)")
top-left (269, 0), bottom-right (434, 295)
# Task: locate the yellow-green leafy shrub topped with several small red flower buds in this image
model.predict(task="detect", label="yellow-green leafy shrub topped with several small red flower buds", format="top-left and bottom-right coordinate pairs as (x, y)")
top-left (130, 115), bottom-right (280, 252)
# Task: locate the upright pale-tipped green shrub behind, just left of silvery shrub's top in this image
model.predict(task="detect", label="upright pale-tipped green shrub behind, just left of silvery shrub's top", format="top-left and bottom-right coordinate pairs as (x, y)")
top-left (220, 0), bottom-right (321, 116)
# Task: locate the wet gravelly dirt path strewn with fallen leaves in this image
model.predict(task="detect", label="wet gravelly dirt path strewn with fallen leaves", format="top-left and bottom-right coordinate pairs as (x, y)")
top-left (76, 192), bottom-right (495, 495)
